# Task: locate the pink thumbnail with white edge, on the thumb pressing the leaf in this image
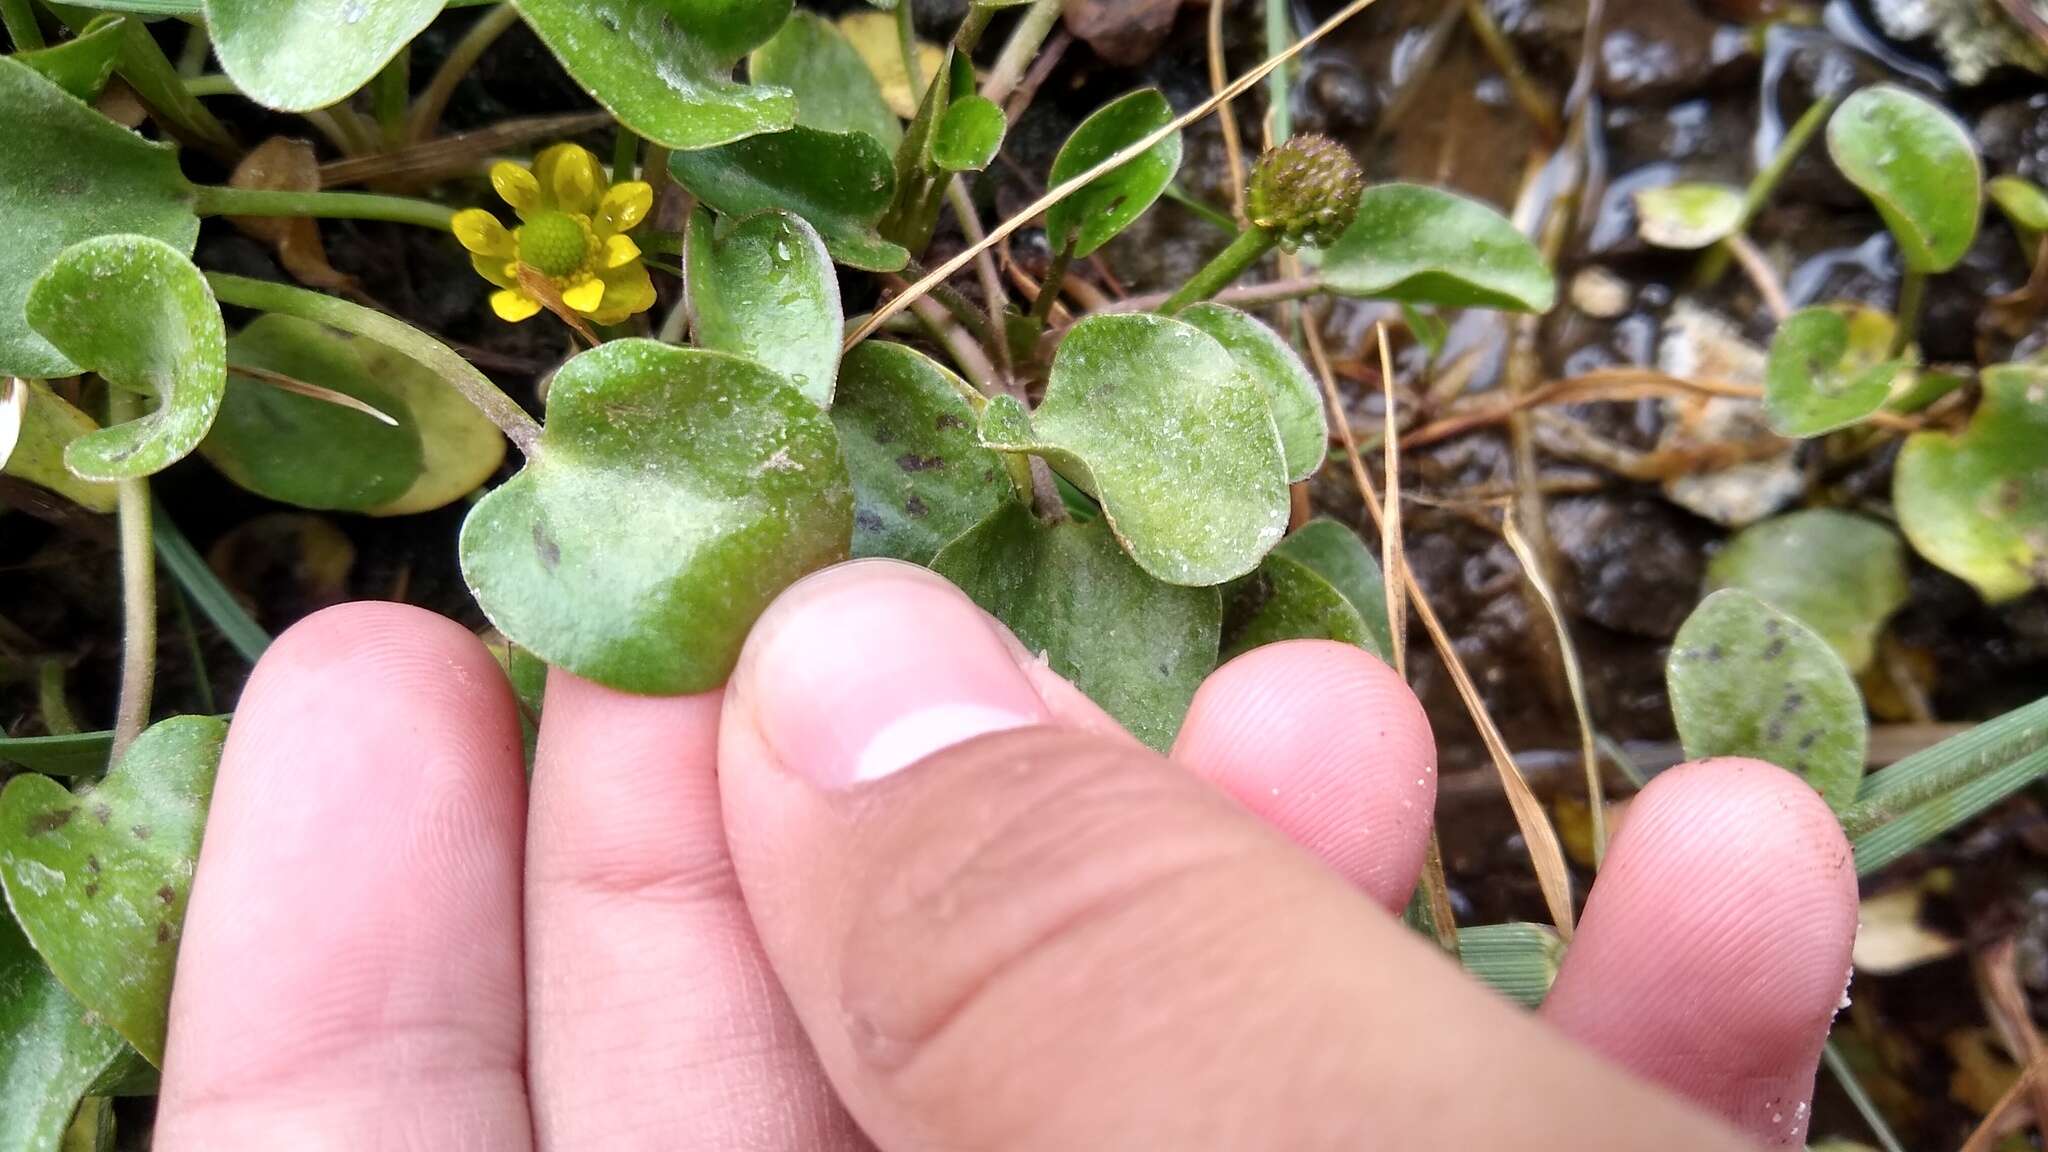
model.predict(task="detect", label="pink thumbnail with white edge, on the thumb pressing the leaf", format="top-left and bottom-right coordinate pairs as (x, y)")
top-left (731, 562), bottom-right (1051, 789)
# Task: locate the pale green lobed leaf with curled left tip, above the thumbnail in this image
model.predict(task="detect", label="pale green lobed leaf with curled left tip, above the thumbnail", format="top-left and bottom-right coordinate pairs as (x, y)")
top-left (981, 314), bottom-right (1288, 584)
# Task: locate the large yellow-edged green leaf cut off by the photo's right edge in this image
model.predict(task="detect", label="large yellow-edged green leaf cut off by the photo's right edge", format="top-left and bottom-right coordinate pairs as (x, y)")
top-left (1892, 365), bottom-right (2048, 603)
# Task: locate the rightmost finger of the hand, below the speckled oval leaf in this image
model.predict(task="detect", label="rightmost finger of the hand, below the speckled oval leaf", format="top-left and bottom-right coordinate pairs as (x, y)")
top-left (1544, 758), bottom-right (1855, 1148)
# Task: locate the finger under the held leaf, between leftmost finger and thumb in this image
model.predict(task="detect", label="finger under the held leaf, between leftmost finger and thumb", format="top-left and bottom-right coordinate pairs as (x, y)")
top-left (526, 670), bottom-right (860, 1152)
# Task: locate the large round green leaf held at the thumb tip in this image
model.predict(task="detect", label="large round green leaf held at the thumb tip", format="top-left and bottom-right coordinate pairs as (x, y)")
top-left (461, 338), bottom-right (854, 693)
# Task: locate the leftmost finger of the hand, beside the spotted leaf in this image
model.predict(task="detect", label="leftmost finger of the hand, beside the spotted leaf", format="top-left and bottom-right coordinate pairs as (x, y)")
top-left (156, 605), bottom-right (528, 1152)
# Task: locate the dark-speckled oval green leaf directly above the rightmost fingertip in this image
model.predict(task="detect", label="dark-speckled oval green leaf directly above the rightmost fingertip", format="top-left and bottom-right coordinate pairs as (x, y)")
top-left (1665, 588), bottom-right (1868, 812)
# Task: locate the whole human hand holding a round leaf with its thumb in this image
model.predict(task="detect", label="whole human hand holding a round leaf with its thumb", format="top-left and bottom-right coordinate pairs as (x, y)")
top-left (156, 562), bottom-right (1855, 1152)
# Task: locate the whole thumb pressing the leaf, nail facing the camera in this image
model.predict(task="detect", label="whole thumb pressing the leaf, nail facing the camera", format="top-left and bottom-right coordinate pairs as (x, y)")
top-left (719, 562), bottom-right (1743, 1152)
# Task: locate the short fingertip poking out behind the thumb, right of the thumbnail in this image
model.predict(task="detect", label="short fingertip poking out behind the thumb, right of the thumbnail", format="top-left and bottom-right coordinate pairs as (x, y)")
top-left (1174, 640), bottom-right (1436, 910)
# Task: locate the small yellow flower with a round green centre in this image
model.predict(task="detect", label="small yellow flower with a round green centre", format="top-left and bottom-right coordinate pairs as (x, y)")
top-left (455, 143), bottom-right (653, 324)
